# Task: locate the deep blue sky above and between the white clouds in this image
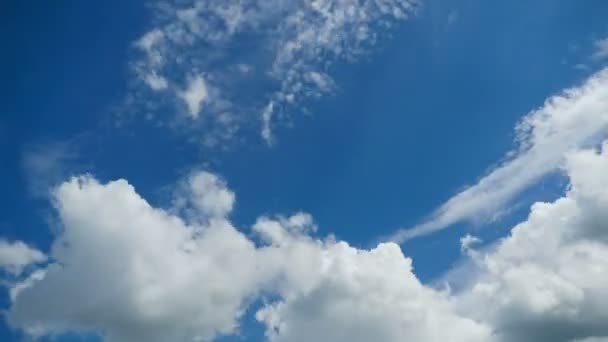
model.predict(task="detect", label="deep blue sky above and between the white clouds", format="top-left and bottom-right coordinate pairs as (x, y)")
top-left (0, 0), bottom-right (608, 341)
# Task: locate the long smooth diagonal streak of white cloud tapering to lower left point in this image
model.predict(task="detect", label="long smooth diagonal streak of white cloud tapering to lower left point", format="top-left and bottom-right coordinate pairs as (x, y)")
top-left (391, 69), bottom-right (608, 241)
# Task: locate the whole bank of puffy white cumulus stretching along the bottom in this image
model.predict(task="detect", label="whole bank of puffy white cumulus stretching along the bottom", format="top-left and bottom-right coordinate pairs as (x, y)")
top-left (7, 146), bottom-right (608, 342)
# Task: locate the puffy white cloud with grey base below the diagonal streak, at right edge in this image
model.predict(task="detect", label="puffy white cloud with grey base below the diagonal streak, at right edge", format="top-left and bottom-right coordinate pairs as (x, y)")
top-left (457, 148), bottom-right (608, 342)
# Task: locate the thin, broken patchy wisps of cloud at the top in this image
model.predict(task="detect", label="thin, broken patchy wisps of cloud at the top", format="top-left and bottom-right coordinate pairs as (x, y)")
top-left (133, 0), bottom-right (418, 142)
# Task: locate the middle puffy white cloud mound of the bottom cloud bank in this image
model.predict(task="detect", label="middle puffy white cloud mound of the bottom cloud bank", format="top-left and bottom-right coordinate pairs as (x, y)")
top-left (256, 242), bottom-right (491, 342)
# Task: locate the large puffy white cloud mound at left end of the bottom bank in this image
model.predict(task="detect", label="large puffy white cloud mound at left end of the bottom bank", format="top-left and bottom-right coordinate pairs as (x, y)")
top-left (9, 177), bottom-right (262, 342)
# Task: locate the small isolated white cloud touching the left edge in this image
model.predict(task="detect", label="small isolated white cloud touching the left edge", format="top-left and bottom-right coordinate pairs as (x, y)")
top-left (0, 239), bottom-right (46, 275)
